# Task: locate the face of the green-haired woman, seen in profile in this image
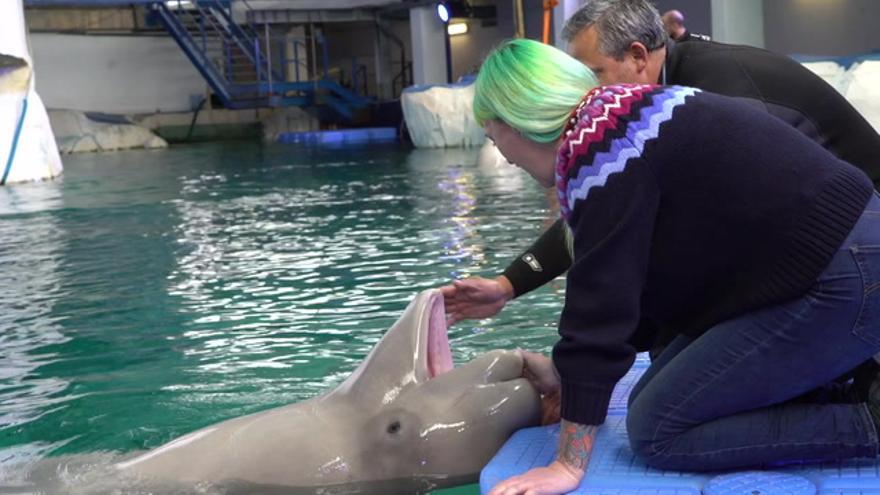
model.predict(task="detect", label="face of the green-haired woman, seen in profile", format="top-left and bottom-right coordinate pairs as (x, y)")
top-left (485, 120), bottom-right (556, 187)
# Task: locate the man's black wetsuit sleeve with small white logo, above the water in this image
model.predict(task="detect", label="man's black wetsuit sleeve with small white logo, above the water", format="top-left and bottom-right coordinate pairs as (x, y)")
top-left (503, 218), bottom-right (571, 297)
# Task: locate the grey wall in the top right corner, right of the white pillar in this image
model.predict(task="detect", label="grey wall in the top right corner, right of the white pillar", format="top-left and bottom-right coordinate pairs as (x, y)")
top-left (764, 0), bottom-right (880, 55)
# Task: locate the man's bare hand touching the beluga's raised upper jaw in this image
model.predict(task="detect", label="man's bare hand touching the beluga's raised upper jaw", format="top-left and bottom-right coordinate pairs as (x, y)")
top-left (440, 275), bottom-right (513, 325)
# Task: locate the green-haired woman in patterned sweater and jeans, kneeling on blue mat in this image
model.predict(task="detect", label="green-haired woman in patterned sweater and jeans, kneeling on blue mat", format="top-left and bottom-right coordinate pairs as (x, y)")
top-left (482, 40), bottom-right (880, 495)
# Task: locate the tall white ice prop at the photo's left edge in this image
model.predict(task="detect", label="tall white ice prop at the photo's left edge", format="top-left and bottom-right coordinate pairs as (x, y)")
top-left (0, 0), bottom-right (62, 184)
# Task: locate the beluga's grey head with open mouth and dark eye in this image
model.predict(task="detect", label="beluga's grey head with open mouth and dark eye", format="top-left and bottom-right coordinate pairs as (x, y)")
top-left (310, 290), bottom-right (541, 481)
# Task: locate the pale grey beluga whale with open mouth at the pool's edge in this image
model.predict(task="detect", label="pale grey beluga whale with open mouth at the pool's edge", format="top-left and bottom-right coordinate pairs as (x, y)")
top-left (117, 290), bottom-right (541, 495)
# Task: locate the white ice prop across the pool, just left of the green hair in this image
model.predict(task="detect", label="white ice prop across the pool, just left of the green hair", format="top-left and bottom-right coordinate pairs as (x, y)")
top-left (400, 84), bottom-right (486, 148)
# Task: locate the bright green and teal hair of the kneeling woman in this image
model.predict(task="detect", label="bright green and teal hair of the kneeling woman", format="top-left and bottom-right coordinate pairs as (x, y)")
top-left (474, 39), bottom-right (599, 143)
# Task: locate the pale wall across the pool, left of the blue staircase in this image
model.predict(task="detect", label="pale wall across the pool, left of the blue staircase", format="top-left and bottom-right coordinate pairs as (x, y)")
top-left (30, 33), bottom-right (207, 113)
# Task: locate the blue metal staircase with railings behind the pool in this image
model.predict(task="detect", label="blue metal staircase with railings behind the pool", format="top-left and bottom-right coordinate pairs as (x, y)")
top-left (151, 0), bottom-right (372, 120)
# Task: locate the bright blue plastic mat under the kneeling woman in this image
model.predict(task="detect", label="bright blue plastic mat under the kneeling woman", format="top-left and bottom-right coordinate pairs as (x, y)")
top-left (480, 358), bottom-right (880, 495)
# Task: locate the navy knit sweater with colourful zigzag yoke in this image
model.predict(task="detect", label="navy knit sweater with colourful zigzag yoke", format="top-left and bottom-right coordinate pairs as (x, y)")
top-left (553, 85), bottom-right (873, 424)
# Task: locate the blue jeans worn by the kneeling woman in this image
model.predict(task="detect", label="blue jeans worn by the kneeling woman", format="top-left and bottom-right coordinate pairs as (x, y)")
top-left (627, 195), bottom-right (880, 470)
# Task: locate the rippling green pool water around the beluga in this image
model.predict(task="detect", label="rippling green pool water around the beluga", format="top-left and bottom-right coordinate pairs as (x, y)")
top-left (0, 142), bottom-right (562, 494)
